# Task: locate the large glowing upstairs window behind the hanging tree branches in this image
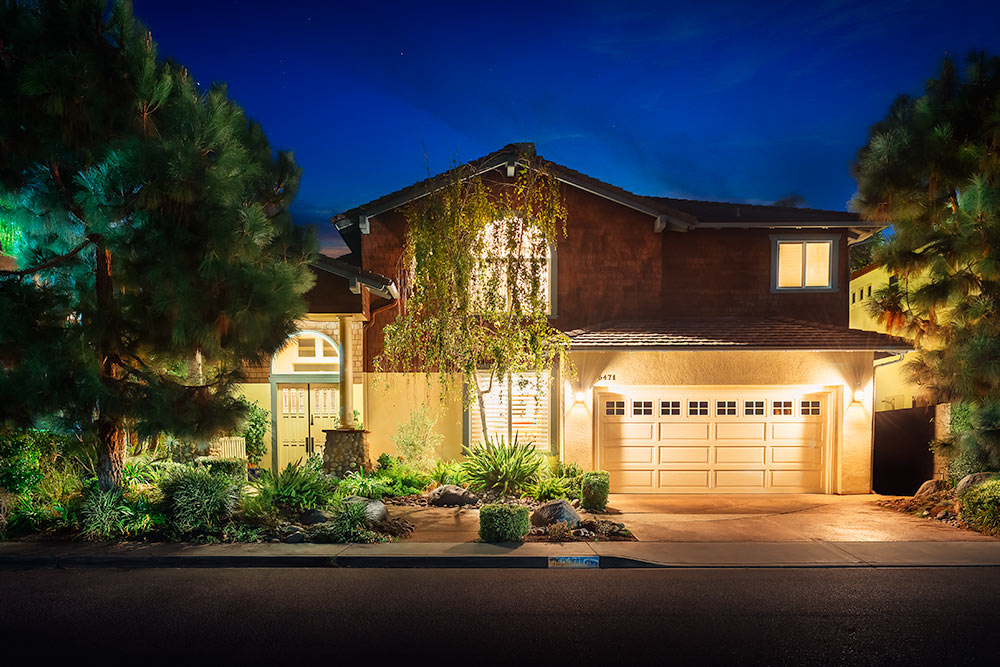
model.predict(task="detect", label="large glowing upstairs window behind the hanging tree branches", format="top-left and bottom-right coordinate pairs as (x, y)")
top-left (475, 219), bottom-right (555, 317)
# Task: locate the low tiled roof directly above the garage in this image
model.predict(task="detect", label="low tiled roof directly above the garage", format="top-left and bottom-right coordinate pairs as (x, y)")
top-left (566, 317), bottom-right (913, 352)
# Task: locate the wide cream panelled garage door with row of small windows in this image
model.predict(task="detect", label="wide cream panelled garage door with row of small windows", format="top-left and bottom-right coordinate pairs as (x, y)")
top-left (595, 387), bottom-right (832, 493)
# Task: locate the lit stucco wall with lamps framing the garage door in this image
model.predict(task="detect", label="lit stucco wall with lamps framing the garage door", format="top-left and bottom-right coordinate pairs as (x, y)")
top-left (561, 351), bottom-right (873, 494)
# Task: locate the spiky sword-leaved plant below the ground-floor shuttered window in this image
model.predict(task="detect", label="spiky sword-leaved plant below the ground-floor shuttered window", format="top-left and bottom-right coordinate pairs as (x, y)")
top-left (462, 435), bottom-right (544, 496)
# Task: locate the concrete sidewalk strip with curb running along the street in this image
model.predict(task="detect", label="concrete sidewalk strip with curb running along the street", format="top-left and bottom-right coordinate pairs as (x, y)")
top-left (0, 540), bottom-right (1000, 570)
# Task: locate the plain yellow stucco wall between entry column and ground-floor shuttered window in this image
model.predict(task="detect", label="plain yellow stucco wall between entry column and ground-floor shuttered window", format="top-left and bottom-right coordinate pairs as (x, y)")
top-left (364, 373), bottom-right (463, 460)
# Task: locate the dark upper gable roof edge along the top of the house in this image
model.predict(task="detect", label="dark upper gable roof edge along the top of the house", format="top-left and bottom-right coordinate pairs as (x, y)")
top-left (330, 143), bottom-right (885, 252)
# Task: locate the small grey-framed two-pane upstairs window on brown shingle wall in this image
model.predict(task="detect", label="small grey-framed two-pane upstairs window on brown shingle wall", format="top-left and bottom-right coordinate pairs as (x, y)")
top-left (771, 234), bottom-right (839, 292)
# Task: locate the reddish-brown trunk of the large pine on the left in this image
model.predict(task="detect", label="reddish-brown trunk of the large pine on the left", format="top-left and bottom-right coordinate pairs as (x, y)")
top-left (94, 240), bottom-right (126, 491)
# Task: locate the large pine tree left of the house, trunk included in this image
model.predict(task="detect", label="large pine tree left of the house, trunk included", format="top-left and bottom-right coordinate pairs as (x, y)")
top-left (0, 0), bottom-right (313, 489)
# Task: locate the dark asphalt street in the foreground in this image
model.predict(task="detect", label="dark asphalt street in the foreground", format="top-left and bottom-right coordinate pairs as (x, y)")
top-left (0, 567), bottom-right (1000, 667)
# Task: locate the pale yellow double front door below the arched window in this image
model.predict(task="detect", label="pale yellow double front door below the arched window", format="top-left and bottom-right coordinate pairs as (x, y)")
top-left (277, 383), bottom-right (340, 470)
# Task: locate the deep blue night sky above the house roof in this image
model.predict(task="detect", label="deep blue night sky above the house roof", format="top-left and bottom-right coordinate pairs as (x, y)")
top-left (134, 0), bottom-right (1000, 255)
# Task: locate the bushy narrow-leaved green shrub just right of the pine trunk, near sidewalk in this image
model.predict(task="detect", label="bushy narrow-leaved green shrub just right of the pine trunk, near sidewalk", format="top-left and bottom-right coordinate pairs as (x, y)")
top-left (161, 467), bottom-right (242, 535)
